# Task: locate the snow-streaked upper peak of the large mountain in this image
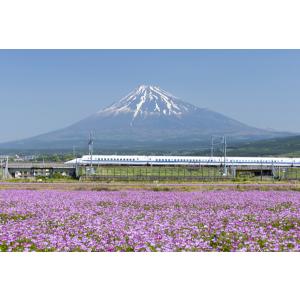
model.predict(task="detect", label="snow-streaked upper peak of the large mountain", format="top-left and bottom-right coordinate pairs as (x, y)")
top-left (99, 85), bottom-right (195, 124)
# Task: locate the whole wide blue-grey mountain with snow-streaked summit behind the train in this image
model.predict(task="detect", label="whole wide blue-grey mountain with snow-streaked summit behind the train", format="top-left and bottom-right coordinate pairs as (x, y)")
top-left (0, 85), bottom-right (288, 150)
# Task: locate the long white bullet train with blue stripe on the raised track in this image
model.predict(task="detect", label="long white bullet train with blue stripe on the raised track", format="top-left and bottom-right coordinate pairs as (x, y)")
top-left (65, 155), bottom-right (300, 167)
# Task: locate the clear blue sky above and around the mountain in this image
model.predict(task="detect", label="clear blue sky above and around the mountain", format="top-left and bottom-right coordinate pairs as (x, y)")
top-left (0, 50), bottom-right (300, 142)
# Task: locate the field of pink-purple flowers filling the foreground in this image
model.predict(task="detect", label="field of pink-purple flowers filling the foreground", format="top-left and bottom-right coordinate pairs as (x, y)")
top-left (0, 190), bottom-right (300, 251)
